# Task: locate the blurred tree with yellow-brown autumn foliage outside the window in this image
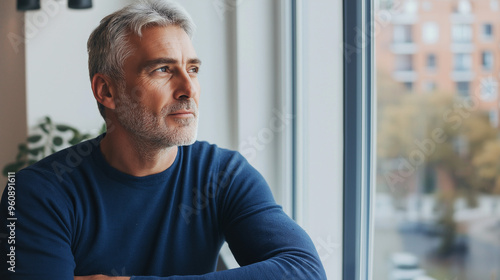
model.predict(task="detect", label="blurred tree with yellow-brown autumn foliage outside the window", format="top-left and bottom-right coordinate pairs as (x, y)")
top-left (376, 71), bottom-right (500, 254)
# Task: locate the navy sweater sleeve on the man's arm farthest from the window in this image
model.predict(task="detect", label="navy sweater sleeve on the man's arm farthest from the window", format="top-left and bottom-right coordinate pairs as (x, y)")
top-left (0, 170), bottom-right (75, 280)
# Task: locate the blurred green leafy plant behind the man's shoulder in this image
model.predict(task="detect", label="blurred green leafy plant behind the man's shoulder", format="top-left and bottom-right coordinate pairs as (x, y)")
top-left (2, 117), bottom-right (106, 176)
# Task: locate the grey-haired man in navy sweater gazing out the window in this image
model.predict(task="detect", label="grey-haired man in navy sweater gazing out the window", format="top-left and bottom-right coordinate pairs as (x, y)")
top-left (0, 1), bottom-right (326, 280)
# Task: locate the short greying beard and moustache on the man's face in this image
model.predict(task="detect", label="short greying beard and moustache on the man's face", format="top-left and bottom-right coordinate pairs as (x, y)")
top-left (115, 87), bottom-right (199, 150)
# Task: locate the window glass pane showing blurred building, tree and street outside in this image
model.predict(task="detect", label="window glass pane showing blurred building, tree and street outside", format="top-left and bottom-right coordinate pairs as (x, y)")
top-left (373, 0), bottom-right (500, 280)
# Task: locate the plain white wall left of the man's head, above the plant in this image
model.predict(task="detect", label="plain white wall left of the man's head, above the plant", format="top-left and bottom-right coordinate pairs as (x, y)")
top-left (26, 0), bottom-right (132, 131)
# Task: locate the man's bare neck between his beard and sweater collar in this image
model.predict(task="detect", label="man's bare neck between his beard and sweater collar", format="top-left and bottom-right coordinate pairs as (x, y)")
top-left (101, 130), bottom-right (178, 177)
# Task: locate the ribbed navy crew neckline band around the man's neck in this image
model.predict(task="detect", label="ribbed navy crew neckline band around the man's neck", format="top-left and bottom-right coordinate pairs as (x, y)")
top-left (92, 133), bottom-right (183, 188)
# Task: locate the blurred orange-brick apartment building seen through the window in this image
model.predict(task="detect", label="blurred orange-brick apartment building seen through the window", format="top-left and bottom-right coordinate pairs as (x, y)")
top-left (375, 0), bottom-right (500, 123)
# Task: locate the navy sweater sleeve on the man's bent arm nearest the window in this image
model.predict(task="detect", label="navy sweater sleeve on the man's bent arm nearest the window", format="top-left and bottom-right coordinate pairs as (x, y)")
top-left (131, 154), bottom-right (326, 280)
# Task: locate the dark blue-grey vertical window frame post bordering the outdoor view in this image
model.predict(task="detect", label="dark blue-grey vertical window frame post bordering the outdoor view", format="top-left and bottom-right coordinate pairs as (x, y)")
top-left (342, 0), bottom-right (375, 280)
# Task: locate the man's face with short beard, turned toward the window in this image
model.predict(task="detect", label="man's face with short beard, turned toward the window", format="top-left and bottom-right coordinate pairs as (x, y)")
top-left (115, 26), bottom-right (200, 148)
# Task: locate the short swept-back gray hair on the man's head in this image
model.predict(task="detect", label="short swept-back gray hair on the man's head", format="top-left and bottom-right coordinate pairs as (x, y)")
top-left (87, 0), bottom-right (195, 118)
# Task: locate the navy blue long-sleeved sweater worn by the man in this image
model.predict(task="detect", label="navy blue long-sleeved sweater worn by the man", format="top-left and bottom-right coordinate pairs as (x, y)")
top-left (0, 137), bottom-right (326, 280)
